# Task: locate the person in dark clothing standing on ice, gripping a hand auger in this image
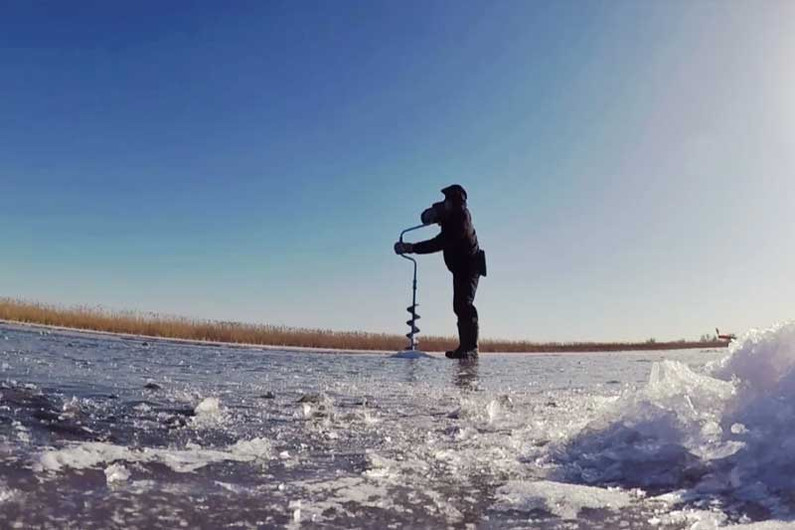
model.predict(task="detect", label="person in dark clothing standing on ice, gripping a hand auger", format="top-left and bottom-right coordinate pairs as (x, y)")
top-left (395, 184), bottom-right (486, 359)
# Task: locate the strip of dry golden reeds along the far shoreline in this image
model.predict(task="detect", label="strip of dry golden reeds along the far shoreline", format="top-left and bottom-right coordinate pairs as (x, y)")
top-left (0, 298), bottom-right (728, 353)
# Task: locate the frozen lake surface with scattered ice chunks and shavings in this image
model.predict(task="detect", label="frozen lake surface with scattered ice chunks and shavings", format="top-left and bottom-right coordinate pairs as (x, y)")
top-left (0, 324), bottom-right (795, 529)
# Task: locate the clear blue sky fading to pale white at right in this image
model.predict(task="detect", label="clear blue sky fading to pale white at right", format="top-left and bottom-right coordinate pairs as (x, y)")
top-left (0, 0), bottom-right (795, 340)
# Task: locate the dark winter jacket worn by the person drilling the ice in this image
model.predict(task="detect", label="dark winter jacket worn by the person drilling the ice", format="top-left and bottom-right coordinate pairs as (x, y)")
top-left (414, 203), bottom-right (485, 275)
